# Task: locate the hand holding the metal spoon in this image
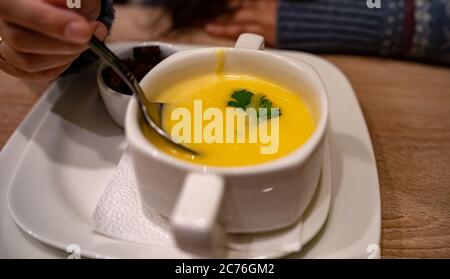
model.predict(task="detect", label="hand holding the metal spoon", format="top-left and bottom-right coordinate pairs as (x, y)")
top-left (0, 0), bottom-right (108, 81)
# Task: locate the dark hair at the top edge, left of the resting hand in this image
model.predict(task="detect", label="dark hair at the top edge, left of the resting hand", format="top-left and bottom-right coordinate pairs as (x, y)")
top-left (164, 0), bottom-right (227, 27)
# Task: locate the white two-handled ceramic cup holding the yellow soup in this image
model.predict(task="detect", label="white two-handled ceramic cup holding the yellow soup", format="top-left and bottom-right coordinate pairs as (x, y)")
top-left (125, 34), bottom-right (328, 255)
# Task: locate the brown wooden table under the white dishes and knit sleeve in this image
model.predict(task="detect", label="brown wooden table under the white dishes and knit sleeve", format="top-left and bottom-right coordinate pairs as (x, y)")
top-left (0, 4), bottom-right (450, 258)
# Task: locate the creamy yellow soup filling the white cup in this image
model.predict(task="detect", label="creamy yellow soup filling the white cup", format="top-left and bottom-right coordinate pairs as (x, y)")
top-left (142, 74), bottom-right (314, 167)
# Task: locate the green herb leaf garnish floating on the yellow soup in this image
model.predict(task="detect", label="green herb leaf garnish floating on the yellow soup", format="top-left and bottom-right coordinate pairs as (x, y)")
top-left (228, 89), bottom-right (281, 119)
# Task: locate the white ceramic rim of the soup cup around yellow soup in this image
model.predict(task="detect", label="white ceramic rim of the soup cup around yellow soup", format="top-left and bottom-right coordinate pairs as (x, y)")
top-left (125, 47), bottom-right (329, 176)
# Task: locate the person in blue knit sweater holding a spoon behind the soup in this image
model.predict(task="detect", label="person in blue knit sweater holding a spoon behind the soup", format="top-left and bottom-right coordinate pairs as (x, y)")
top-left (0, 0), bottom-right (450, 80)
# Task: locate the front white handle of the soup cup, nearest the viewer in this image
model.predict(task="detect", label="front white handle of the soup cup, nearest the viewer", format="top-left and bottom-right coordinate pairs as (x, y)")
top-left (171, 173), bottom-right (225, 256)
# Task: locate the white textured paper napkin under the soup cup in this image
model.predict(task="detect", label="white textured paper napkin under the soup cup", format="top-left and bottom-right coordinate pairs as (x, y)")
top-left (92, 153), bottom-right (302, 257)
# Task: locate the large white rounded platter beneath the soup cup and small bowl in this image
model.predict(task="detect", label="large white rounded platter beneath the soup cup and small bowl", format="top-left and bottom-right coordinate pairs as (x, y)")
top-left (0, 44), bottom-right (380, 258)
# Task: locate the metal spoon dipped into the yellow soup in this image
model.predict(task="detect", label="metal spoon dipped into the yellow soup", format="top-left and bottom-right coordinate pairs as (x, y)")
top-left (89, 36), bottom-right (198, 155)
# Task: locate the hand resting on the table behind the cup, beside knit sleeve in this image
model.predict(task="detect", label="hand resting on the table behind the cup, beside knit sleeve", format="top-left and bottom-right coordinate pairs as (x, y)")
top-left (205, 0), bottom-right (278, 45)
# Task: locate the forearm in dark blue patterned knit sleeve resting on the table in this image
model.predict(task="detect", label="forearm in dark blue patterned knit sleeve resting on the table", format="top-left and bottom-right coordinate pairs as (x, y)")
top-left (277, 0), bottom-right (450, 63)
